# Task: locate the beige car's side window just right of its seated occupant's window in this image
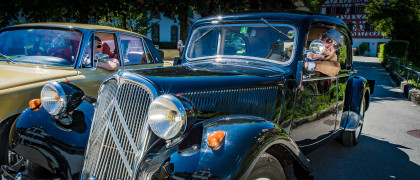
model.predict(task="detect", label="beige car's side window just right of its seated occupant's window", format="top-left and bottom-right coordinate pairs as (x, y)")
top-left (120, 35), bottom-right (148, 65)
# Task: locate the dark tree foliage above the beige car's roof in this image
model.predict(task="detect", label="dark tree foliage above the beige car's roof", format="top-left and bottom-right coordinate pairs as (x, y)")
top-left (0, 0), bottom-right (151, 33)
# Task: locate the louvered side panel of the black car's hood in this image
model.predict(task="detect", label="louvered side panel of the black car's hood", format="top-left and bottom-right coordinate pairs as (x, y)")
top-left (183, 86), bottom-right (279, 120)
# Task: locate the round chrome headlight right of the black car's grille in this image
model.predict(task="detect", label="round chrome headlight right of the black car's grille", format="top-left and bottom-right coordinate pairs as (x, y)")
top-left (147, 94), bottom-right (187, 140)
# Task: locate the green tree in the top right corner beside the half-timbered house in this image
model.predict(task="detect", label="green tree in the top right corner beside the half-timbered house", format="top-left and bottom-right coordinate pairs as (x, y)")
top-left (365, 0), bottom-right (420, 65)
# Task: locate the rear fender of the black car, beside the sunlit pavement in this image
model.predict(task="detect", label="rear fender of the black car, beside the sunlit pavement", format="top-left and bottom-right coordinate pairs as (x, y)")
top-left (340, 76), bottom-right (375, 130)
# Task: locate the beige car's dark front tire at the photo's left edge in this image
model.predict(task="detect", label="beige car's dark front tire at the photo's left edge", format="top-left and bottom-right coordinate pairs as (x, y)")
top-left (0, 118), bottom-right (15, 165)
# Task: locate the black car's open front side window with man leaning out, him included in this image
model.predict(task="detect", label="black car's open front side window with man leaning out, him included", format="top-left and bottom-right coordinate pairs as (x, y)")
top-left (304, 25), bottom-right (347, 77)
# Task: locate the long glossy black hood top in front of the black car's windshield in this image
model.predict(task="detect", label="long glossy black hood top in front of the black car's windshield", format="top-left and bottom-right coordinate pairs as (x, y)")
top-left (129, 63), bottom-right (284, 94)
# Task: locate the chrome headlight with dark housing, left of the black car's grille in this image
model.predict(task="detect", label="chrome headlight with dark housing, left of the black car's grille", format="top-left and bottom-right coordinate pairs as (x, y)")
top-left (41, 81), bottom-right (84, 116)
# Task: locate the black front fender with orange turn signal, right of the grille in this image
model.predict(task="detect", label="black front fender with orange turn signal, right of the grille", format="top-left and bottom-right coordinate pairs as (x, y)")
top-left (167, 115), bottom-right (312, 179)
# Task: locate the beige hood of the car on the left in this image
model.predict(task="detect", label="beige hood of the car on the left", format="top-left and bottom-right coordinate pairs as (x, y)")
top-left (0, 62), bottom-right (77, 90)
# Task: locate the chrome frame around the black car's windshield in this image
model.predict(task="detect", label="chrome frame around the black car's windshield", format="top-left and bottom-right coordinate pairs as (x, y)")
top-left (184, 22), bottom-right (299, 66)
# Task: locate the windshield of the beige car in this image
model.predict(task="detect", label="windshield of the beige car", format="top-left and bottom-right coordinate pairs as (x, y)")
top-left (0, 29), bottom-right (82, 66)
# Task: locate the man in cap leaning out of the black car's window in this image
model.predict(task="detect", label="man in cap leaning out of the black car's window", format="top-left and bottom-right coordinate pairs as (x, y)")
top-left (305, 29), bottom-right (343, 77)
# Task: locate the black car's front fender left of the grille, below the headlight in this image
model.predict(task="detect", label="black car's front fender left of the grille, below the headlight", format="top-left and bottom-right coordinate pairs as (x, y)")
top-left (10, 101), bottom-right (94, 179)
